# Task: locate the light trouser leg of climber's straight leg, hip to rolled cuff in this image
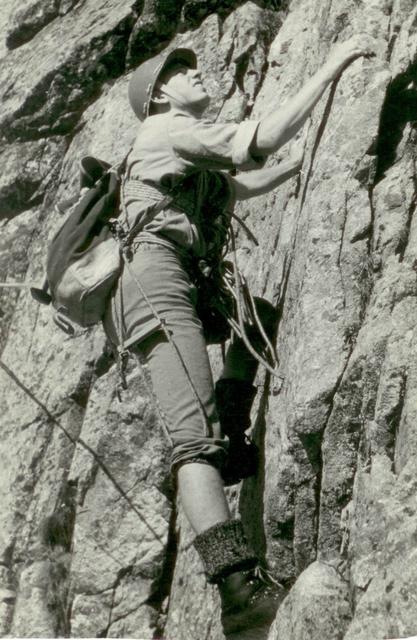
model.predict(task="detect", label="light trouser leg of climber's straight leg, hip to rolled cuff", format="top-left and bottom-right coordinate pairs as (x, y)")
top-left (128, 245), bottom-right (227, 467)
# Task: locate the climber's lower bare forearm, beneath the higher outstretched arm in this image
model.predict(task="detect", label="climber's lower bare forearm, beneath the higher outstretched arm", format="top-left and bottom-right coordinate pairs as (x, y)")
top-left (232, 160), bottom-right (301, 200)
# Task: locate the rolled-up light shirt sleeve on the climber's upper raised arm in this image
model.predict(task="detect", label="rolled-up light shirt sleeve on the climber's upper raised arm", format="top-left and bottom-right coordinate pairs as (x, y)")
top-left (169, 115), bottom-right (259, 169)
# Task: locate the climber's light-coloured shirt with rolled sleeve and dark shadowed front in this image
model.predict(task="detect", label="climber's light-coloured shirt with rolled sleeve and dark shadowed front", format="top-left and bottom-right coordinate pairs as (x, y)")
top-left (124, 112), bottom-right (259, 256)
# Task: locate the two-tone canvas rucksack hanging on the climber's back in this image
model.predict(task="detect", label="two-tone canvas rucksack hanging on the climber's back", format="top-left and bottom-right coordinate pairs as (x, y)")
top-left (35, 156), bottom-right (126, 331)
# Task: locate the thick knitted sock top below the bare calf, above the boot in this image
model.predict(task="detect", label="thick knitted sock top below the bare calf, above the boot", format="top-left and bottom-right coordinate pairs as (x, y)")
top-left (194, 520), bottom-right (258, 584)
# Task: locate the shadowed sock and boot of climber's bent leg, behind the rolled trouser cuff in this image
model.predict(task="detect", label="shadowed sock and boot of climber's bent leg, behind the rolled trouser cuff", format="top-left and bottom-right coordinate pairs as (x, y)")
top-left (215, 378), bottom-right (259, 486)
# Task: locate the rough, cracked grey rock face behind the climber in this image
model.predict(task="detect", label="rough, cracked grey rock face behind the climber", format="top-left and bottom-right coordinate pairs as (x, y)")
top-left (0, 0), bottom-right (417, 640)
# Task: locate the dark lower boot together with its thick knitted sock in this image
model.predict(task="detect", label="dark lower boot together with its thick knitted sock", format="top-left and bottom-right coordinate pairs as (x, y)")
top-left (194, 520), bottom-right (284, 635)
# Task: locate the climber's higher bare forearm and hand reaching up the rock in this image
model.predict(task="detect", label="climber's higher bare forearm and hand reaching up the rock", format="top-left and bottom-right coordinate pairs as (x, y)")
top-left (251, 36), bottom-right (372, 156)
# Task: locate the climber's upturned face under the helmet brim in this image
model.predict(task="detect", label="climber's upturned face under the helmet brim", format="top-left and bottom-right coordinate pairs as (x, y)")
top-left (153, 62), bottom-right (210, 115)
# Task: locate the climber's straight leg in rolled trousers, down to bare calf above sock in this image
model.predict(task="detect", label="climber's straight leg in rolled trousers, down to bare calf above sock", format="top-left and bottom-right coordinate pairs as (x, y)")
top-left (125, 246), bottom-right (230, 533)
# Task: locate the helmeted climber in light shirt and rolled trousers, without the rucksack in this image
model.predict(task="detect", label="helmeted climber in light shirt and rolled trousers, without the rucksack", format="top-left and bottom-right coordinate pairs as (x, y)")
top-left (105, 38), bottom-right (370, 634)
